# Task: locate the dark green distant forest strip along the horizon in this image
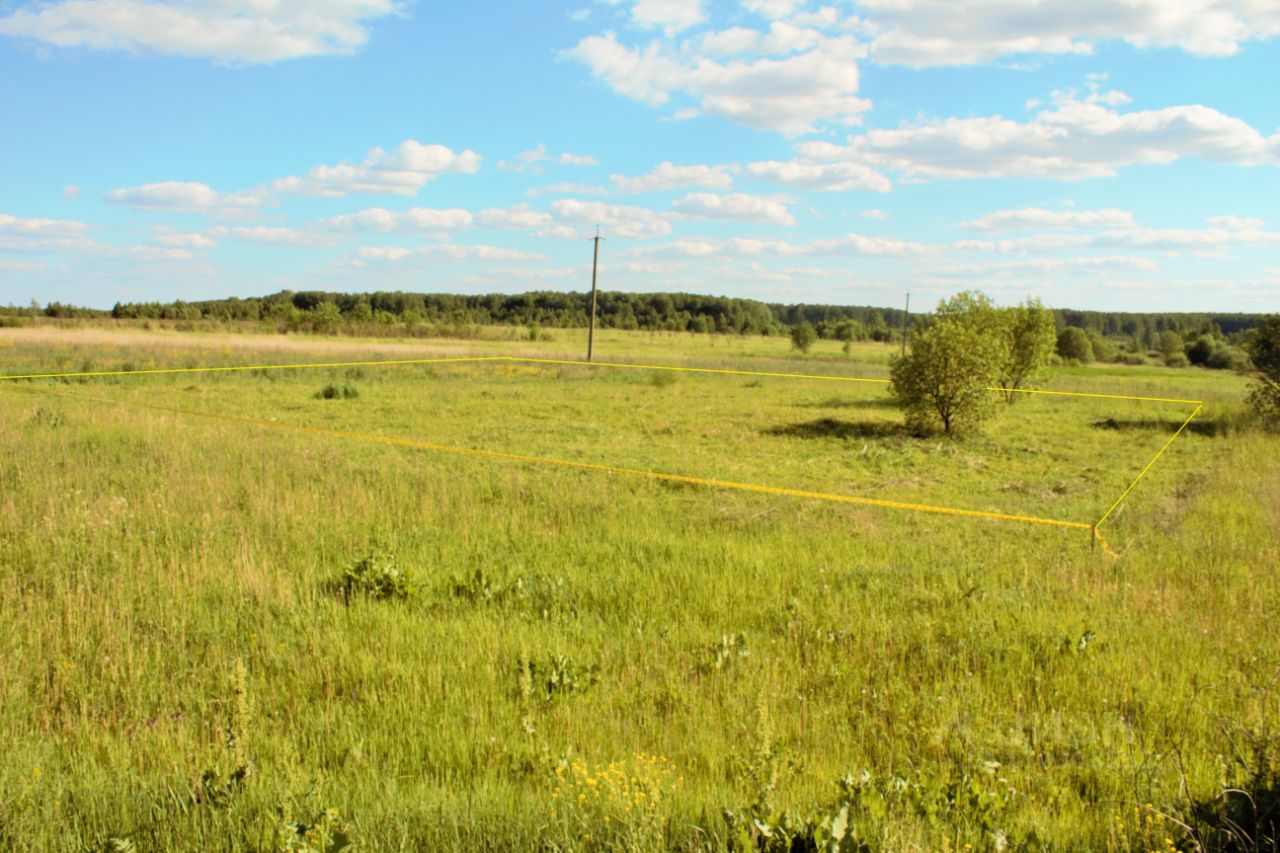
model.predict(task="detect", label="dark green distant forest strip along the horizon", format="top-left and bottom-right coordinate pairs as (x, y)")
top-left (0, 291), bottom-right (1263, 347)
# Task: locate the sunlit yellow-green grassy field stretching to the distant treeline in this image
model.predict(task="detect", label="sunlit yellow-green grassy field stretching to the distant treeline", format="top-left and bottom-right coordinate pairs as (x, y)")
top-left (0, 322), bottom-right (1280, 850)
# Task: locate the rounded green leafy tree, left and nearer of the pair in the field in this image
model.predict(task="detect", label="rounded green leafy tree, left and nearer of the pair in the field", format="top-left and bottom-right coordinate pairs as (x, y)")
top-left (890, 315), bottom-right (1004, 434)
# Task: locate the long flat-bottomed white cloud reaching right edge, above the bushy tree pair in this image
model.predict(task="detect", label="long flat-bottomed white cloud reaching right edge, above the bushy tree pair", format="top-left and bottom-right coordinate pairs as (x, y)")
top-left (797, 82), bottom-right (1280, 181)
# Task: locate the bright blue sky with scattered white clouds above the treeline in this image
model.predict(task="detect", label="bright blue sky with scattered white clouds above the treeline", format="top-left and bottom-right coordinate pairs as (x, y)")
top-left (0, 0), bottom-right (1280, 311)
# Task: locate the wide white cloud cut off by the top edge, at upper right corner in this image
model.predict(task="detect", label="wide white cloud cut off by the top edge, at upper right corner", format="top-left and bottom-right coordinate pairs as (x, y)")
top-left (859, 0), bottom-right (1280, 67)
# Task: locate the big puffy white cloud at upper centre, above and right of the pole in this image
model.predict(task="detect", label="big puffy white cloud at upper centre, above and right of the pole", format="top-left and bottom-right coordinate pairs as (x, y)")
top-left (564, 32), bottom-right (870, 136)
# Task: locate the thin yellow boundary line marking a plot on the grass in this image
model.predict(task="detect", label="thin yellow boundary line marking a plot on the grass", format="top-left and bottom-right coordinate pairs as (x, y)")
top-left (0, 356), bottom-right (1204, 557)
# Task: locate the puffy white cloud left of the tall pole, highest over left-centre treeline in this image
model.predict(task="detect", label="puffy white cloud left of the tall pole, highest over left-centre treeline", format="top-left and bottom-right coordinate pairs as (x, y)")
top-left (271, 140), bottom-right (480, 197)
